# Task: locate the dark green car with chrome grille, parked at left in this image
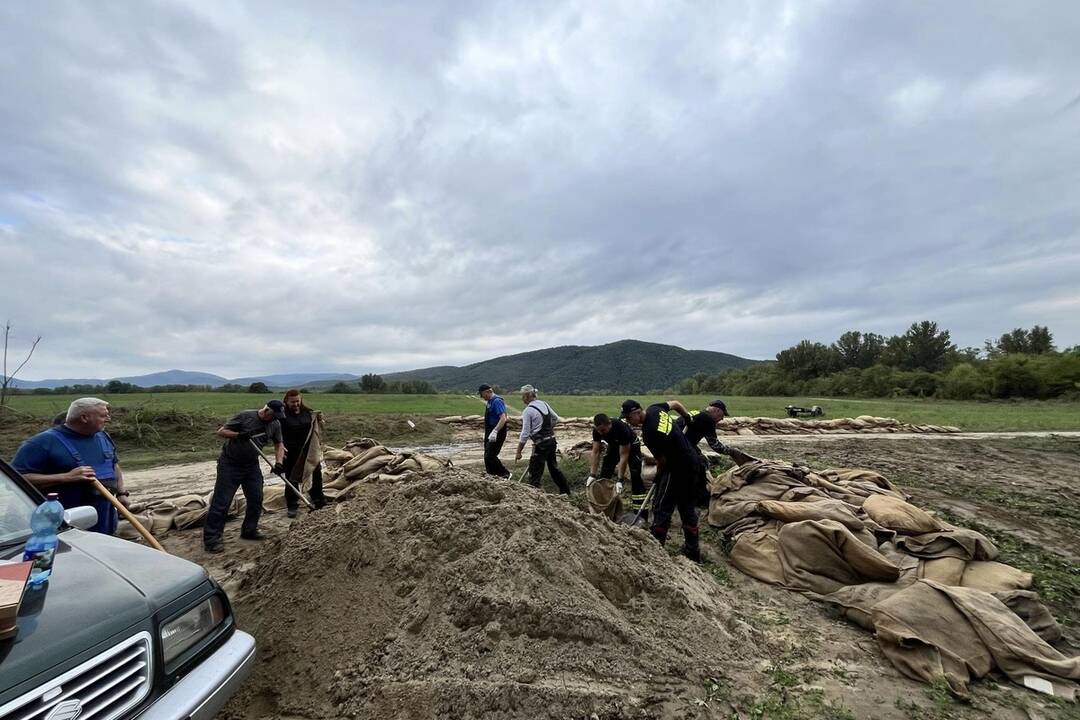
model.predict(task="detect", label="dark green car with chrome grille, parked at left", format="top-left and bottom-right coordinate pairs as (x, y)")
top-left (0, 460), bottom-right (255, 720)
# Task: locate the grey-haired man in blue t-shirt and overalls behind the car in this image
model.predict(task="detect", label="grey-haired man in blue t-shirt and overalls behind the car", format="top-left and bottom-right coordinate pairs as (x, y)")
top-left (11, 397), bottom-right (131, 535)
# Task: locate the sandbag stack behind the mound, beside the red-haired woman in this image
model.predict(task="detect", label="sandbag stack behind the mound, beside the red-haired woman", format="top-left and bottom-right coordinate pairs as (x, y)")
top-left (323, 437), bottom-right (446, 500)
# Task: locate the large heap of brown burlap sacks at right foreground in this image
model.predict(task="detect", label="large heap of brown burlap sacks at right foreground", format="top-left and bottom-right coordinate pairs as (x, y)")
top-left (707, 461), bottom-right (1080, 699)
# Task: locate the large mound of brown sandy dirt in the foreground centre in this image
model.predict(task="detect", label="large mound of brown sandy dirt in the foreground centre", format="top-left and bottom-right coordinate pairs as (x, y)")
top-left (226, 470), bottom-right (760, 718)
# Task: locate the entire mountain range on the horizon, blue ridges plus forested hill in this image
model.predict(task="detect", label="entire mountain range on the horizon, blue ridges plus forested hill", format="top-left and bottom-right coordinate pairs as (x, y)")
top-left (13, 340), bottom-right (759, 394)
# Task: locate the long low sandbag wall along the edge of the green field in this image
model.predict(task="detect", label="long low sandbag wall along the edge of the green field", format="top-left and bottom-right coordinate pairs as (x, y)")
top-left (436, 415), bottom-right (960, 435)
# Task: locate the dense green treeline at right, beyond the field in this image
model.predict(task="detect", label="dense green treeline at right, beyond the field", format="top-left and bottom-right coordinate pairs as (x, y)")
top-left (675, 321), bottom-right (1080, 399)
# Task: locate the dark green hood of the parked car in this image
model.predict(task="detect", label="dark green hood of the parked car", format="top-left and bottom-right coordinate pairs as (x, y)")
top-left (0, 528), bottom-right (207, 696)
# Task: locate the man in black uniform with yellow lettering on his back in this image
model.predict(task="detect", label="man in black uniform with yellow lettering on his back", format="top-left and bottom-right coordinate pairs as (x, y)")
top-left (622, 399), bottom-right (701, 562)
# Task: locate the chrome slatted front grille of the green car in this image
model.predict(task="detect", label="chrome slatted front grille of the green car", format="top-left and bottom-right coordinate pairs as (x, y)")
top-left (0, 633), bottom-right (153, 720)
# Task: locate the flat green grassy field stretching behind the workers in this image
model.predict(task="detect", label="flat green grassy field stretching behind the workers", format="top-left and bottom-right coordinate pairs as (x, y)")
top-left (2, 393), bottom-right (1080, 432)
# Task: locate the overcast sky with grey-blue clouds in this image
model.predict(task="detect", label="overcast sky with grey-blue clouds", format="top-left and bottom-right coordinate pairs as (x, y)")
top-left (0, 0), bottom-right (1080, 379)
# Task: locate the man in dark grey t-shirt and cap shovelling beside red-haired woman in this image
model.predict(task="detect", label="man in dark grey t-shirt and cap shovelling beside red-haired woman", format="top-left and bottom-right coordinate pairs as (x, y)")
top-left (203, 400), bottom-right (285, 553)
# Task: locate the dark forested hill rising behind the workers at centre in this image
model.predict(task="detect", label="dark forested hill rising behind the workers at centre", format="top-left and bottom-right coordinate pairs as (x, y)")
top-left (383, 340), bottom-right (757, 394)
